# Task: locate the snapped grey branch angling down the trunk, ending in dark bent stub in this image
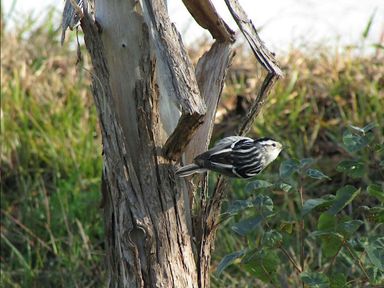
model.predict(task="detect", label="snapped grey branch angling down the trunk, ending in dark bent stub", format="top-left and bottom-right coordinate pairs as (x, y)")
top-left (143, 0), bottom-right (206, 160)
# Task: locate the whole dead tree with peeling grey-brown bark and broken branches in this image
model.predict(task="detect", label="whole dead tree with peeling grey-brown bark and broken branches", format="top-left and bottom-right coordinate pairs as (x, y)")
top-left (63, 0), bottom-right (281, 287)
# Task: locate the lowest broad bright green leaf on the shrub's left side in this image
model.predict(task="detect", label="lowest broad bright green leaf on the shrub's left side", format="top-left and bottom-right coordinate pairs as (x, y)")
top-left (242, 249), bottom-right (281, 283)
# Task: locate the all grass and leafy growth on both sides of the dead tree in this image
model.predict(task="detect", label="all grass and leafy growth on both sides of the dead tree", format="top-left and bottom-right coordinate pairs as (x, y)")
top-left (0, 10), bottom-right (384, 287)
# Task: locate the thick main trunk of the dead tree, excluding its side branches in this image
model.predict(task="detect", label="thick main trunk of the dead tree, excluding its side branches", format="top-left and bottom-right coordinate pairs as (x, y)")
top-left (81, 0), bottom-right (197, 287)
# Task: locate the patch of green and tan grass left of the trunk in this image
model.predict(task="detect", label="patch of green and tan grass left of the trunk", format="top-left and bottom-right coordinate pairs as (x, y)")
top-left (0, 10), bottom-right (104, 287)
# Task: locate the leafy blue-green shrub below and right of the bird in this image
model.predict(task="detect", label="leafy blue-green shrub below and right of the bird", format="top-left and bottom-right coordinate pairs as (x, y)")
top-left (219, 124), bottom-right (384, 287)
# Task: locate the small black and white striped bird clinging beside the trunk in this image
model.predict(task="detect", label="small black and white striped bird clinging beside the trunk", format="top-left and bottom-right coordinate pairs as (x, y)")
top-left (176, 136), bottom-right (283, 178)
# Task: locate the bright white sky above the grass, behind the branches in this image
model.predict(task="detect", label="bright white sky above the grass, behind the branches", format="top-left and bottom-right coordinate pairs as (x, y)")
top-left (2, 0), bottom-right (384, 50)
